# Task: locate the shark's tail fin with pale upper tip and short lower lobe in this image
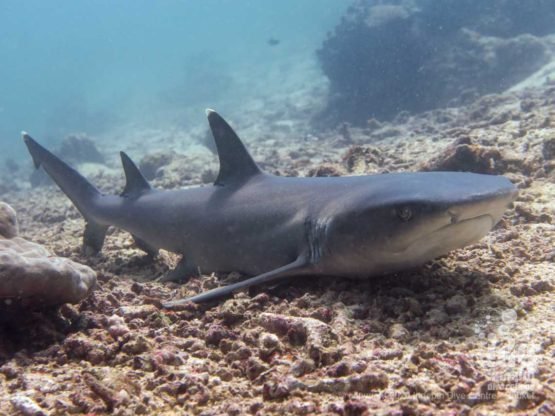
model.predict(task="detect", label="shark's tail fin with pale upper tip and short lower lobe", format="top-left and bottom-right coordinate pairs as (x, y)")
top-left (22, 132), bottom-right (108, 254)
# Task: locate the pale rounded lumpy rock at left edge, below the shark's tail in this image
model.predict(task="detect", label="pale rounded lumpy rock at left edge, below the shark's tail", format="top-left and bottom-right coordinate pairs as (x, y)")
top-left (0, 202), bottom-right (96, 306)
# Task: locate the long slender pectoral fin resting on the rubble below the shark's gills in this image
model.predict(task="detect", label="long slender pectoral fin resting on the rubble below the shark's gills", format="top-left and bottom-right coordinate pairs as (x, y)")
top-left (162, 256), bottom-right (311, 308)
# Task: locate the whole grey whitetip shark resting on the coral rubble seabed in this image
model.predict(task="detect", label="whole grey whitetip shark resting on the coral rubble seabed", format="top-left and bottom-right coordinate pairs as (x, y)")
top-left (23, 110), bottom-right (517, 307)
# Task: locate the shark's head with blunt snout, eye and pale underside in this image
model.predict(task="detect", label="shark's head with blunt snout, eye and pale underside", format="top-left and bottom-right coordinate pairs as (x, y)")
top-left (329, 172), bottom-right (517, 275)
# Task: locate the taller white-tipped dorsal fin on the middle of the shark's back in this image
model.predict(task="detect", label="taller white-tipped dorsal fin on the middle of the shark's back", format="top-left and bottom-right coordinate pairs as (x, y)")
top-left (206, 109), bottom-right (262, 185)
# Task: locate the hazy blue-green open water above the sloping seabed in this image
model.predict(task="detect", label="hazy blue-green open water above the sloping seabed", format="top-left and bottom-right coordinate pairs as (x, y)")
top-left (0, 0), bottom-right (348, 157)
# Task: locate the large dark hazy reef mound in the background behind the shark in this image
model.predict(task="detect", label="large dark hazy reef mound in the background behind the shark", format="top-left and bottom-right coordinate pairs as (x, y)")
top-left (315, 0), bottom-right (555, 126)
